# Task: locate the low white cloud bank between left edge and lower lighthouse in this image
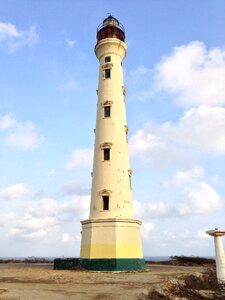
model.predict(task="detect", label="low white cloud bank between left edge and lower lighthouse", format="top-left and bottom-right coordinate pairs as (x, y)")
top-left (0, 179), bottom-right (90, 245)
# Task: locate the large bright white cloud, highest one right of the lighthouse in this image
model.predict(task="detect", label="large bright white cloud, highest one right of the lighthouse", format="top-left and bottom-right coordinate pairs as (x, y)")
top-left (126, 41), bottom-right (225, 107)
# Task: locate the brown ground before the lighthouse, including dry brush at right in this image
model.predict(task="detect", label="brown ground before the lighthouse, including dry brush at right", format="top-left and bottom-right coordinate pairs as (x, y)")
top-left (0, 263), bottom-right (225, 300)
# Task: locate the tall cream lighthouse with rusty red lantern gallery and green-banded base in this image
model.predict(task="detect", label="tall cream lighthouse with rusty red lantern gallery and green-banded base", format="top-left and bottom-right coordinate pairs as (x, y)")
top-left (80, 16), bottom-right (144, 270)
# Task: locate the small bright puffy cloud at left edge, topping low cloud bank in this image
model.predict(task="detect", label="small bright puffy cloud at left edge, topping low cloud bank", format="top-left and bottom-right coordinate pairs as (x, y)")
top-left (0, 183), bottom-right (32, 200)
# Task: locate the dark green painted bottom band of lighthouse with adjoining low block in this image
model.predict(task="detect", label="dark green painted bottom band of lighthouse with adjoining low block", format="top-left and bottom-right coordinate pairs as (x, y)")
top-left (54, 258), bottom-right (145, 271)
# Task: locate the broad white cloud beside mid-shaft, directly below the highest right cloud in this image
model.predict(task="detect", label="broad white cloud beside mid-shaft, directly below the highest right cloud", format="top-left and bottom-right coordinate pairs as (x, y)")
top-left (130, 106), bottom-right (225, 167)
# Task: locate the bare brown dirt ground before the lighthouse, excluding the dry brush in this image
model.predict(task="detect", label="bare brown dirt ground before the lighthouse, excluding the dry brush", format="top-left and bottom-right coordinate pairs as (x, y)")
top-left (0, 263), bottom-right (209, 300)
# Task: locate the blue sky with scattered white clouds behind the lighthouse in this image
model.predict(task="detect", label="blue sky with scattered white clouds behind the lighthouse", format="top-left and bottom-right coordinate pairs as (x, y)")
top-left (0, 0), bottom-right (225, 257)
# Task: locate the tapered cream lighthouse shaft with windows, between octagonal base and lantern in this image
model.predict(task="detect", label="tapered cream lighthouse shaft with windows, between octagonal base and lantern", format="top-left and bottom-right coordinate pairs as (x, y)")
top-left (90, 38), bottom-right (133, 218)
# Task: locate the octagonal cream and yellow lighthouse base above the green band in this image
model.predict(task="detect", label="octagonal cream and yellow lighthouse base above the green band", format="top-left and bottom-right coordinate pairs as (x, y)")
top-left (80, 218), bottom-right (143, 260)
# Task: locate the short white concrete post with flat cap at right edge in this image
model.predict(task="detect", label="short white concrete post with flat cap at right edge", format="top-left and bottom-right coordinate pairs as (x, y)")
top-left (206, 228), bottom-right (225, 289)
